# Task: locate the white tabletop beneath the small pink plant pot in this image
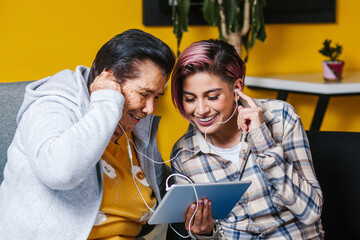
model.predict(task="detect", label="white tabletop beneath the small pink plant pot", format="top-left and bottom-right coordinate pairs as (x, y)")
top-left (245, 72), bottom-right (360, 94)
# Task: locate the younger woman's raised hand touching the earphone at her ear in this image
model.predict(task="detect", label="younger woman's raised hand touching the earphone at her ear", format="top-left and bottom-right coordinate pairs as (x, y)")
top-left (237, 91), bottom-right (264, 133)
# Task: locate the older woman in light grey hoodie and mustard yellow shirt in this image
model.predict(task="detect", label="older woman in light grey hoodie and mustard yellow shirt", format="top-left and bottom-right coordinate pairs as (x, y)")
top-left (0, 29), bottom-right (175, 240)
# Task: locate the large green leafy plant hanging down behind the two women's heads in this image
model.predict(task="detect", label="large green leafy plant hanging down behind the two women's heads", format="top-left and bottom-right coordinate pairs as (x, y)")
top-left (172, 0), bottom-right (266, 61)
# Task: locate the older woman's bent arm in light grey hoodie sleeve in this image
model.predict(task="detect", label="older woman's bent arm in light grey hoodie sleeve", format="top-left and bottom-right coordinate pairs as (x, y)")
top-left (20, 89), bottom-right (124, 190)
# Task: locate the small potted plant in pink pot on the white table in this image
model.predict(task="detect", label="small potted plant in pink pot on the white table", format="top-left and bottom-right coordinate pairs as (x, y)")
top-left (319, 39), bottom-right (344, 81)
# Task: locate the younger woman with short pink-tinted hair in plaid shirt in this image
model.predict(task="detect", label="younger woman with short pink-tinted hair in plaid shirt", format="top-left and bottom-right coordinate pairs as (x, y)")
top-left (171, 40), bottom-right (324, 240)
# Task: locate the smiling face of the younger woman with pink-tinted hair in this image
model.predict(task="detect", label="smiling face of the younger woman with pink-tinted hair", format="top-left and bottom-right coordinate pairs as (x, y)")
top-left (183, 72), bottom-right (234, 134)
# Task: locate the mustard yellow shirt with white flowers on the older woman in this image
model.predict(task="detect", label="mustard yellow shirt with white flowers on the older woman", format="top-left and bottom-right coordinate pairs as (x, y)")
top-left (89, 133), bottom-right (156, 240)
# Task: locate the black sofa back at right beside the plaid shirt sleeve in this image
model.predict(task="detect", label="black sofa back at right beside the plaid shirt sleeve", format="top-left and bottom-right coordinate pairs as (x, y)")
top-left (307, 131), bottom-right (360, 240)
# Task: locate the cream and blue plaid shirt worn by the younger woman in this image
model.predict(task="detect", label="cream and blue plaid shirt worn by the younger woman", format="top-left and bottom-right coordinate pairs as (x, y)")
top-left (171, 99), bottom-right (324, 239)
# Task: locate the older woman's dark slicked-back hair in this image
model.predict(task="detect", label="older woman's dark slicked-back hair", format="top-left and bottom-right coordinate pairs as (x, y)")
top-left (88, 29), bottom-right (175, 86)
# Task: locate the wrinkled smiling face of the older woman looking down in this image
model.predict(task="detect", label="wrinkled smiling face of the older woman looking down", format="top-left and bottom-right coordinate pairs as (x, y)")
top-left (120, 61), bottom-right (166, 131)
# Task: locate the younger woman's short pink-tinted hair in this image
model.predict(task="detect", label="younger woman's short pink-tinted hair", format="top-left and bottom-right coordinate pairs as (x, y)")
top-left (171, 39), bottom-right (246, 116)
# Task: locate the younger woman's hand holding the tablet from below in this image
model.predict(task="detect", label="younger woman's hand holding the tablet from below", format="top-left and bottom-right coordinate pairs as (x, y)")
top-left (185, 199), bottom-right (215, 236)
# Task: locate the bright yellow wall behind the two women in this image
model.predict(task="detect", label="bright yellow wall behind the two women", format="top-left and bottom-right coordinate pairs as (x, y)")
top-left (0, 0), bottom-right (360, 158)
